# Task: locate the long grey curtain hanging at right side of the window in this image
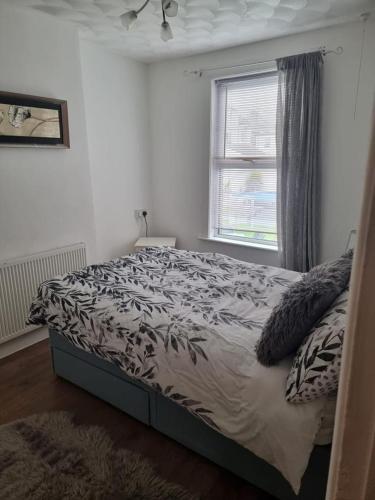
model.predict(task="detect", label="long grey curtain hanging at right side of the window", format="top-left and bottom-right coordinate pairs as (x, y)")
top-left (276, 52), bottom-right (323, 272)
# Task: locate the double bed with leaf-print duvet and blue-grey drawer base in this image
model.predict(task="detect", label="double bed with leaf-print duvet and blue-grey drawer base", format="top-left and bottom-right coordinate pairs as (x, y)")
top-left (30, 248), bottom-right (330, 500)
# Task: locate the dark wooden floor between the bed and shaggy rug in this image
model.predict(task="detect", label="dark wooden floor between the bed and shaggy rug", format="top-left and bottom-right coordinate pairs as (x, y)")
top-left (0, 340), bottom-right (274, 500)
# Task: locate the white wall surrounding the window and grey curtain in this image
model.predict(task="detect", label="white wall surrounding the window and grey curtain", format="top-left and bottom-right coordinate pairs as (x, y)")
top-left (150, 21), bottom-right (375, 265)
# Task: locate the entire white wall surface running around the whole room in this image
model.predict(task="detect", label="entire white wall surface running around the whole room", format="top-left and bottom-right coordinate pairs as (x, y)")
top-left (0, 7), bottom-right (375, 272)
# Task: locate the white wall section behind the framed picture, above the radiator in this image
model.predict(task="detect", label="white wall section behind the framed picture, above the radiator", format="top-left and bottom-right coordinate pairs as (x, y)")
top-left (0, 6), bottom-right (95, 260)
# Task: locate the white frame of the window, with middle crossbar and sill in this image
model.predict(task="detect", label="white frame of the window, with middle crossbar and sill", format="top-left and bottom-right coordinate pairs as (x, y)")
top-left (209, 67), bottom-right (279, 252)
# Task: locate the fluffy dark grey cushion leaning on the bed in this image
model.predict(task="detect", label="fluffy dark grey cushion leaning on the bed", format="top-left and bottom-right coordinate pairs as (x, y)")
top-left (256, 250), bottom-right (353, 366)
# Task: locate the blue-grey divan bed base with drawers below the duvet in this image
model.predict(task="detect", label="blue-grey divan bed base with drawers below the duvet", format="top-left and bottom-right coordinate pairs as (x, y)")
top-left (50, 330), bottom-right (331, 500)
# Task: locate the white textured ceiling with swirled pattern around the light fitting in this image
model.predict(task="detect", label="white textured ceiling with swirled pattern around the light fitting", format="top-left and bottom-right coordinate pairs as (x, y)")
top-left (6, 0), bottom-right (374, 62)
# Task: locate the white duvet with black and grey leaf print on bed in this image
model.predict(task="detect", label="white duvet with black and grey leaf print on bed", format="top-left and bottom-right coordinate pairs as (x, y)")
top-left (30, 248), bottom-right (323, 491)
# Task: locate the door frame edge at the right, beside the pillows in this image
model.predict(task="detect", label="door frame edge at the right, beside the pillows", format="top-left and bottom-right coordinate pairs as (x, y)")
top-left (326, 108), bottom-right (375, 500)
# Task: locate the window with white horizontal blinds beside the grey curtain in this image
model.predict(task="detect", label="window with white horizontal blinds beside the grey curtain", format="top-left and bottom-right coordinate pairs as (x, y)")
top-left (210, 72), bottom-right (278, 248)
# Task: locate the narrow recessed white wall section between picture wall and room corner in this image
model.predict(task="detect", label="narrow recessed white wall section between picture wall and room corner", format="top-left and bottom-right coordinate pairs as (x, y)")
top-left (81, 42), bottom-right (151, 260)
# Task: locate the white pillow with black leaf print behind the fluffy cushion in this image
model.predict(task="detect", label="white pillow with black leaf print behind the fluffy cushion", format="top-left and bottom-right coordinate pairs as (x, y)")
top-left (286, 290), bottom-right (349, 403)
